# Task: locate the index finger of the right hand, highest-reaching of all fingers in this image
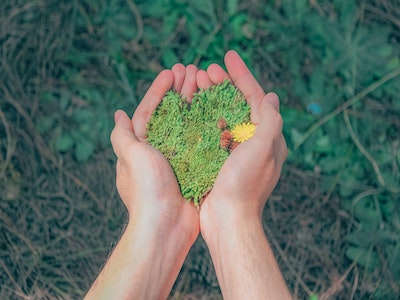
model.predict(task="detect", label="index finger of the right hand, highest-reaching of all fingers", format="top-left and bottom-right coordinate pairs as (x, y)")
top-left (225, 50), bottom-right (265, 112)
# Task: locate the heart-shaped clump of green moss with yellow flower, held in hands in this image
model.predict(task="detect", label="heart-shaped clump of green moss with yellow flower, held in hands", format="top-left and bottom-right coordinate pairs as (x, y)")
top-left (147, 81), bottom-right (254, 207)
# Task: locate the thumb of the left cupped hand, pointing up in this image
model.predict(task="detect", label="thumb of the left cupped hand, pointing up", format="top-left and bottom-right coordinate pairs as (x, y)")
top-left (110, 110), bottom-right (138, 159)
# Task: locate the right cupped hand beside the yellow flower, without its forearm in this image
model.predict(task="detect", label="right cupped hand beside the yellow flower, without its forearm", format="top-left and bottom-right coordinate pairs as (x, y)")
top-left (197, 51), bottom-right (287, 230)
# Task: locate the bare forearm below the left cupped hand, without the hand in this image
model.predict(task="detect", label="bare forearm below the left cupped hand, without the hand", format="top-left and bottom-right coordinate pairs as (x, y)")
top-left (85, 219), bottom-right (193, 299)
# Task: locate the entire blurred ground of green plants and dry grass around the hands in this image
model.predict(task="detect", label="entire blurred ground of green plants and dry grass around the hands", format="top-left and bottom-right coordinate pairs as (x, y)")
top-left (0, 0), bottom-right (400, 299)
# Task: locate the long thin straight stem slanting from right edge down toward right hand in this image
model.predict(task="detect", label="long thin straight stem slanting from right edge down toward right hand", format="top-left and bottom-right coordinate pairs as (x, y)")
top-left (294, 68), bottom-right (400, 150)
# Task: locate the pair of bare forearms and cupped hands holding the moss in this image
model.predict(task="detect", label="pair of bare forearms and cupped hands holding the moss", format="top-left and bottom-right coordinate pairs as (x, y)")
top-left (85, 51), bottom-right (290, 299)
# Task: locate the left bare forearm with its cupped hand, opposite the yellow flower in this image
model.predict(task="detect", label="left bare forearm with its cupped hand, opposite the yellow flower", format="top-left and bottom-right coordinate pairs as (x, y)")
top-left (85, 64), bottom-right (199, 299)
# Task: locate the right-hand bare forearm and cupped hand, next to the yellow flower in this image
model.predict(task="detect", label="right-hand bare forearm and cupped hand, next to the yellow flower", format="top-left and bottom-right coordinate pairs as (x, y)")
top-left (197, 51), bottom-right (291, 299)
